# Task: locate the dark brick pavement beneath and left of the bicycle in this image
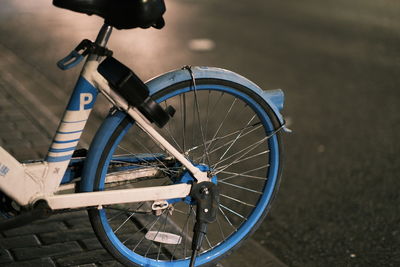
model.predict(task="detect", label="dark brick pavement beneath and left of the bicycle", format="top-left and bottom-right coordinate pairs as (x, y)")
top-left (0, 43), bottom-right (285, 267)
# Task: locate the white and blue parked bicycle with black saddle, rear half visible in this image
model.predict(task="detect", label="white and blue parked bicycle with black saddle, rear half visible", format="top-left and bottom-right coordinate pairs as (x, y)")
top-left (0, 0), bottom-right (288, 266)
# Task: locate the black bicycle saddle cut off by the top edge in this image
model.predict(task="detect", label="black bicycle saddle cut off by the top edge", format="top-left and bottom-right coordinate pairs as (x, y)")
top-left (53, 0), bottom-right (165, 29)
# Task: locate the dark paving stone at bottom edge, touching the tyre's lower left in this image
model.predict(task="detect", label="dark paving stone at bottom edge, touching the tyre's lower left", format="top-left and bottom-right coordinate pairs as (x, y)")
top-left (55, 249), bottom-right (112, 267)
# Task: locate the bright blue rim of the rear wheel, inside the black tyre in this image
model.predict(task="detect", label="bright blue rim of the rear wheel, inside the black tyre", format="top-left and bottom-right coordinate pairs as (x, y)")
top-left (99, 84), bottom-right (280, 267)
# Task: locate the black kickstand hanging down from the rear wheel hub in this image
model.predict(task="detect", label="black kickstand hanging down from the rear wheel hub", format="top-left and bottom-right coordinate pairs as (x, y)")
top-left (189, 182), bottom-right (219, 267)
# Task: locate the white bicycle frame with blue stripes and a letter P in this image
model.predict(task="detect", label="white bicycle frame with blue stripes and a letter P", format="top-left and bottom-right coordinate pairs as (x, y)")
top-left (0, 25), bottom-right (206, 213)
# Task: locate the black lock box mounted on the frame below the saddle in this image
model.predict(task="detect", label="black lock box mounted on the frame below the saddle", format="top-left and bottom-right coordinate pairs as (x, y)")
top-left (97, 57), bottom-right (175, 128)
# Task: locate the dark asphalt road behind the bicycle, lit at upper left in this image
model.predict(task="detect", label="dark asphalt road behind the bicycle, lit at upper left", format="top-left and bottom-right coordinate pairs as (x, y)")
top-left (0, 0), bottom-right (400, 266)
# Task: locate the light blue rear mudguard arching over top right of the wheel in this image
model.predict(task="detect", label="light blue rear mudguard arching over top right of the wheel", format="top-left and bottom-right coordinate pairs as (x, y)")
top-left (146, 67), bottom-right (284, 126)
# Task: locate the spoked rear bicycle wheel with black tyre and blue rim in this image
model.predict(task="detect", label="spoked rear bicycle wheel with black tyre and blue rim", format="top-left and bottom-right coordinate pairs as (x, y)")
top-left (89, 79), bottom-right (281, 266)
